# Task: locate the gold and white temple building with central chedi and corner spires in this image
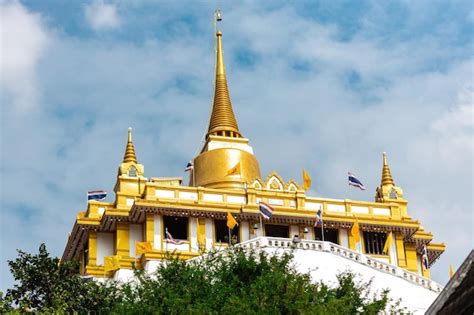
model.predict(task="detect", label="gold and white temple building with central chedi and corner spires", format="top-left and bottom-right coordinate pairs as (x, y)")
top-left (62, 15), bottom-right (445, 308)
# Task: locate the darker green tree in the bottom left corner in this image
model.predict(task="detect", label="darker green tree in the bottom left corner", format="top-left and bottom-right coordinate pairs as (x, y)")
top-left (0, 244), bottom-right (120, 313)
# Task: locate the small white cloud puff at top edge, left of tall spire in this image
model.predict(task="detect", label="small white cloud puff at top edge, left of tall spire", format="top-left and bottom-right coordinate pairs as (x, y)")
top-left (84, 0), bottom-right (120, 31)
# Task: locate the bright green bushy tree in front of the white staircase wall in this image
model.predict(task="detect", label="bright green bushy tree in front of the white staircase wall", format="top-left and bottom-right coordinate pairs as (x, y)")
top-left (114, 247), bottom-right (400, 314)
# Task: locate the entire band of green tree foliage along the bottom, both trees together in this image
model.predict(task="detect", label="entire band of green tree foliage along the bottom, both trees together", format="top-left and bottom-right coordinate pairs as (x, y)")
top-left (0, 245), bottom-right (404, 314)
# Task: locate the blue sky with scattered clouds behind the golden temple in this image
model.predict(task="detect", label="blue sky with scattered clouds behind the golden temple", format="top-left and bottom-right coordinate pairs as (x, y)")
top-left (0, 0), bottom-right (474, 289)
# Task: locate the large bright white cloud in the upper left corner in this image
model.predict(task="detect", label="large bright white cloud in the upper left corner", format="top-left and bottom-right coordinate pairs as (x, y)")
top-left (0, 2), bottom-right (49, 112)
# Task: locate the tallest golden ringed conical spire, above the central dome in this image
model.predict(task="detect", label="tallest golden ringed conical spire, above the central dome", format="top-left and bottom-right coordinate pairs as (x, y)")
top-left (207, 32), bottom-right (242, 138)
